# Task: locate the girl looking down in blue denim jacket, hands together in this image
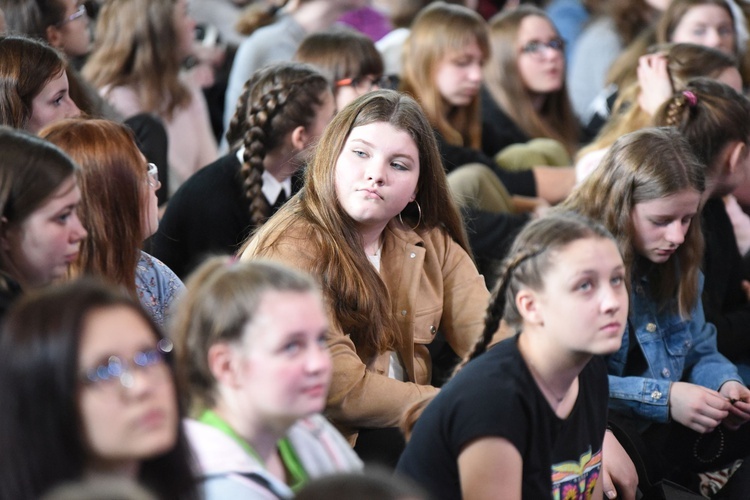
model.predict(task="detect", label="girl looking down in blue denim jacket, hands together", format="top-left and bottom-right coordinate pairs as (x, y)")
top-left (565, 125), bottom-right (750, 498)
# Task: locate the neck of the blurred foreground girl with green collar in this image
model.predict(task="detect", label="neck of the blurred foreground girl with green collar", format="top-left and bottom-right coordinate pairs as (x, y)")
top-left (213, 401), bottom-right (291, 463)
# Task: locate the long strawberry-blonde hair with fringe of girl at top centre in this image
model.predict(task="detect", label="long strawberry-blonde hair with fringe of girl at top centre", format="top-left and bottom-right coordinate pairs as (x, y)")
top-left (401, 2), bottom-right (490, 149)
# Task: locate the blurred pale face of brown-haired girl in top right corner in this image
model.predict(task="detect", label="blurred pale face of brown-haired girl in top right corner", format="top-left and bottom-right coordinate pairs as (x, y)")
top-left (670, 5), bottom-right (737, 55)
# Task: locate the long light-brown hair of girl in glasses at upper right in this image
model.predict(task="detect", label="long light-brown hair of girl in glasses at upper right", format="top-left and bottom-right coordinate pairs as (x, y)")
top-left (484, 4), bottom-right (579, 155)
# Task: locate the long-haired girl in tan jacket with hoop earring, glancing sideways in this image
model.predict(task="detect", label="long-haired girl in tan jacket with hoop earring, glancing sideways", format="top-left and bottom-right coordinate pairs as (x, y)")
top-left (241, 90), bottom-right (489, 465)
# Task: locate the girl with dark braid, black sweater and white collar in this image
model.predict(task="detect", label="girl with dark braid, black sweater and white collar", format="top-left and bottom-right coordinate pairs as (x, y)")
top-left (152, 63), bottom-right (335, 277)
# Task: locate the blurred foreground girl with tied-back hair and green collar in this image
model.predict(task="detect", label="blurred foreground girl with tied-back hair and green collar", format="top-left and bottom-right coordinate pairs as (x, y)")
top-left (173, 257), bottom-right (362, 500)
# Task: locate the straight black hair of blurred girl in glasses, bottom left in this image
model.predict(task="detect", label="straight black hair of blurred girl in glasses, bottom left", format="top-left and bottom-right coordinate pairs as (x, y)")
top-left (0, 279), bottom-right (198, 500)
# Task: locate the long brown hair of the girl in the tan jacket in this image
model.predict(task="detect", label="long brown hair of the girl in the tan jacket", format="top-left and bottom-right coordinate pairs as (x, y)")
top-left (240, 90), bottom-right (469, 362)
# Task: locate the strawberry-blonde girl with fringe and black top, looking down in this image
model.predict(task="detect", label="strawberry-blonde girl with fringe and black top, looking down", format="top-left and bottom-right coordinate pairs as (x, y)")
top-left (401, 2), bottom-right (574, 211)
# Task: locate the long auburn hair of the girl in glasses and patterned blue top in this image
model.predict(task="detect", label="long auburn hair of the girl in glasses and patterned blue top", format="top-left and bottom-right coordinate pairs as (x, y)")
top-left (39, 118), bottom-right (149, 294)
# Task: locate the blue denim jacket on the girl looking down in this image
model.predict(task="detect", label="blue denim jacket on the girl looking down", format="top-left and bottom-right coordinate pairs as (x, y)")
top-left (607, 274), bottom-right (743, 422)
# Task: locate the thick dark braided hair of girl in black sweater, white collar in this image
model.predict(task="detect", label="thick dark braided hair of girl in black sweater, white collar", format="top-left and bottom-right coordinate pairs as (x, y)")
top-left (227, 63), bottom-right (330, 227)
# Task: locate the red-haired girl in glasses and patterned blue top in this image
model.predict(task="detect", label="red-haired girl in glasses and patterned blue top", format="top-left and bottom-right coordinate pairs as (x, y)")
top-left (40, 119), bottom-right (184, 324)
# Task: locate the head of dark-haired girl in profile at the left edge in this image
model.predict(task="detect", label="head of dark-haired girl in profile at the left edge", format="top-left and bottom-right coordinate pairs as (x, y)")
top-left (0, 127), bottom-right (86, 316)
